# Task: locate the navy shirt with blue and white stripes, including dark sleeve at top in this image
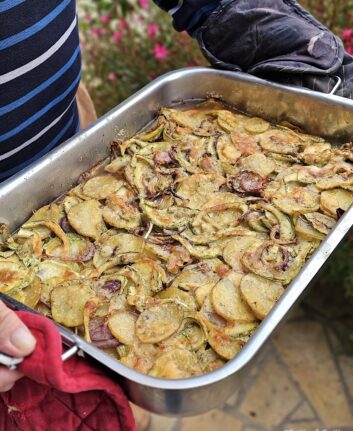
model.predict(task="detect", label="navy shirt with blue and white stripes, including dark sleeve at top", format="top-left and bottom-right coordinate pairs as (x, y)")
top-left (0, 0), bottom-right (219, 181)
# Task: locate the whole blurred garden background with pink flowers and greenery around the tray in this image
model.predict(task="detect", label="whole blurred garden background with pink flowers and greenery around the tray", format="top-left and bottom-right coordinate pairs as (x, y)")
top-left (78, 0), bottom-right (353, 354)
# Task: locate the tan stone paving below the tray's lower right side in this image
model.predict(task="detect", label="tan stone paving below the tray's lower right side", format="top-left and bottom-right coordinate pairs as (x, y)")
top-left (142, 309), bottom-right (353, 431)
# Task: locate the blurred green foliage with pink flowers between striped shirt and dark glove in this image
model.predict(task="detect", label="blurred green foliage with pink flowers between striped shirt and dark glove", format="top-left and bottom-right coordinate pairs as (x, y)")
top-left (78, 0), bottom-right (206, 115)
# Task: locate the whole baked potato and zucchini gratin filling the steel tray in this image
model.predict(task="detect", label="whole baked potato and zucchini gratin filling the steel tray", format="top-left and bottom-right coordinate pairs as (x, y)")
top-left (0, 101), bottom-right (353, 378)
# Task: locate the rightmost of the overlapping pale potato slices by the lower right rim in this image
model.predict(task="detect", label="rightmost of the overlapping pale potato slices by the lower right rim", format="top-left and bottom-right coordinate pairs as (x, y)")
top-left (240, 274), bottom-right (284, 320)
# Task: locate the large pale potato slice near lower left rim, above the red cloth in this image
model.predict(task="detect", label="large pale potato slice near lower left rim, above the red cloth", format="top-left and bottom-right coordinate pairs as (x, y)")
top-left (51, 280), bottom-right (95, 328)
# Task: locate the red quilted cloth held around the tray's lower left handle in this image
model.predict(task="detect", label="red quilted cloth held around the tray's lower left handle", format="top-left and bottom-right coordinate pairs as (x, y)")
top-left (0, 312), bottom-right (136, 431)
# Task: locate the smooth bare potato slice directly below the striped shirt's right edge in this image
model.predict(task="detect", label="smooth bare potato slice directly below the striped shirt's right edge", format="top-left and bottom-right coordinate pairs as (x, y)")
top-left (67, 200), bottom-right (105, 239)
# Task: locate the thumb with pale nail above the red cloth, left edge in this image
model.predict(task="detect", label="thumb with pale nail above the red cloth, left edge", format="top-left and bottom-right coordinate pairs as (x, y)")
top-left (0, 301), bottom-right (36, 356)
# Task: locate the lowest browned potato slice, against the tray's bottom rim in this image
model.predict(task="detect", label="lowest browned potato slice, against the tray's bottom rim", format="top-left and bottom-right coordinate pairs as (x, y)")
top-left (149, 349), bottom-right (202, 379)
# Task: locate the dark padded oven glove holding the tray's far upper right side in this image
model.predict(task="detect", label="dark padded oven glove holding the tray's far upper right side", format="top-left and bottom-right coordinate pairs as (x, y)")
top-left (194, 0), bottom-right (353, 98)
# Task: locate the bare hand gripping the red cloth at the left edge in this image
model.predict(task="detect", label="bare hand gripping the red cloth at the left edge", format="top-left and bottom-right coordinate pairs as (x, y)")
top-left (0, 301), bottom-right (36, 392)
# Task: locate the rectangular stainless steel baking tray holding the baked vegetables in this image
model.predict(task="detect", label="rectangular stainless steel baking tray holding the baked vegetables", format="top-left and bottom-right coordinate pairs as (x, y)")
top-left (0, 68), bottom-right (353, 415)
